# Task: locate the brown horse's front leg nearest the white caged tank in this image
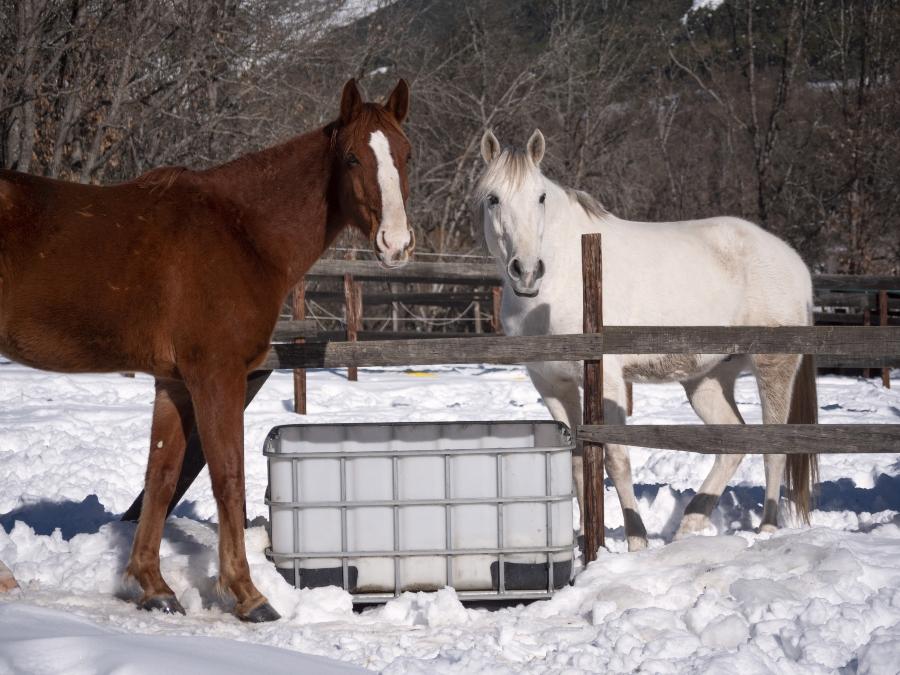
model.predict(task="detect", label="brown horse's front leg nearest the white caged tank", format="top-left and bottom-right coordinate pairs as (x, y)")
top-left (189, 368), bottom-right (280, 623)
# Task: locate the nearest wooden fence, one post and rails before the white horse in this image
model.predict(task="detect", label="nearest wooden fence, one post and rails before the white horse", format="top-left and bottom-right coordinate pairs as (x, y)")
top-left (262, 234), bottom-right (900, 561)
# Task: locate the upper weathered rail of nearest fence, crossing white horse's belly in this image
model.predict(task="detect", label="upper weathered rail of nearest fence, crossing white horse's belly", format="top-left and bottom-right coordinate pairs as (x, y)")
top-left (260, 326), bottom-right (900, 370)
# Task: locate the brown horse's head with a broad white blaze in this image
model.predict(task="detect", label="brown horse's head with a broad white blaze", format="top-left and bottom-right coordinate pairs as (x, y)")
top-left (331, 80), bottom-right (415, 267)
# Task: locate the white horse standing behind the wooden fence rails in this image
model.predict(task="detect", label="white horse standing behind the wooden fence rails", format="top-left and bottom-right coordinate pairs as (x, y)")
top-left (475, 130), bottom-right (817, 551)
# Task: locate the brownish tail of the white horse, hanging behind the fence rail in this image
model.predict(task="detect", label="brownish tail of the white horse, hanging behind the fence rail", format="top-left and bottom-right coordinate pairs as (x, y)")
top-left (785, 355), bottom-right (819, 523)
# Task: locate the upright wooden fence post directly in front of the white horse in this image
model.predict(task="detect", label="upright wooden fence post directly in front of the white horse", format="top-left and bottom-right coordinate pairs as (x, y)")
top-left (581, 232), bottom-right (606, 563)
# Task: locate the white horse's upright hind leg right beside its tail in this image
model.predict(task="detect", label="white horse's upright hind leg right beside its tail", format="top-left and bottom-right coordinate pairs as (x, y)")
top-left (751, 354), bottom-right (801, 532)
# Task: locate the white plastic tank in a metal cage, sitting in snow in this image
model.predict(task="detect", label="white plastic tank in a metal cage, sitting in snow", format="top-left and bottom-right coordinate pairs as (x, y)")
top-left (264, 421), bottom-right (574, 603)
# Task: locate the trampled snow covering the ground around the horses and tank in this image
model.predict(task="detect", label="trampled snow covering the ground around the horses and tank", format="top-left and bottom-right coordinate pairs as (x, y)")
top-left (0, 361), bottom-right (900, 675)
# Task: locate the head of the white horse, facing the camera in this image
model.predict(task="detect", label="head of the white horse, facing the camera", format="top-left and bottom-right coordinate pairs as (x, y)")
top-left (475, 129), bottom-right (547, 297)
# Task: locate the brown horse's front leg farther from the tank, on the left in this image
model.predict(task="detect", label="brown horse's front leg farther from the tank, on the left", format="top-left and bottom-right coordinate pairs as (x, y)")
top-left (127, 380), bottom-right (193, 614)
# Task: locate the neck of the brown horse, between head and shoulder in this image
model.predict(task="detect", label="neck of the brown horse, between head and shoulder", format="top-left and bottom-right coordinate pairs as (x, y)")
top-left (204, 129), bottom-right (343, 289)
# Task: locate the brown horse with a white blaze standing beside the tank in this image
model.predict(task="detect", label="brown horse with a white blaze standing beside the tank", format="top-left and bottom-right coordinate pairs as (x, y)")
top-left (0, 80), bottom-right (414, 622)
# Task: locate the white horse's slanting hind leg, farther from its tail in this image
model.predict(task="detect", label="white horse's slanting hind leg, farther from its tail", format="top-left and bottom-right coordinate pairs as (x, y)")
top-left (675, 357), bottom-right (746, 539)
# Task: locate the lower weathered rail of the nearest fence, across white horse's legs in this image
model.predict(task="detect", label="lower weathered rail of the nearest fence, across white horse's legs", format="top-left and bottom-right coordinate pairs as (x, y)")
top-left (577, 424), bottom-right (900, 455)
